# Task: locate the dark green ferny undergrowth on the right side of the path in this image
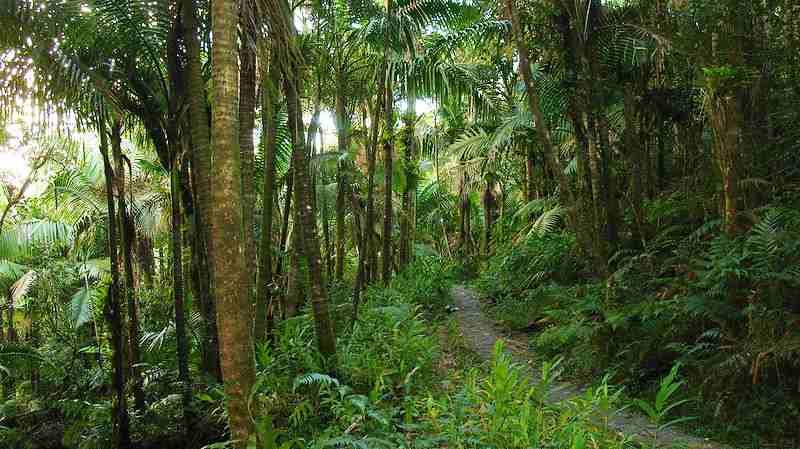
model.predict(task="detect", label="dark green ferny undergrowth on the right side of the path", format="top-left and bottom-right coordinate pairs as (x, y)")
top-left (475, 200), bottom-right (800, 448)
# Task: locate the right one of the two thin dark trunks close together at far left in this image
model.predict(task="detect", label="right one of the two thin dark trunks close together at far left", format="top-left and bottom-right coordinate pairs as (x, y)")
top-left (111, 119), bottom-right (145, 411)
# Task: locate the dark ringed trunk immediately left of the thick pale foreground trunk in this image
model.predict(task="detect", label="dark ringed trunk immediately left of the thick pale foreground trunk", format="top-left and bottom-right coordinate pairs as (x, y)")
top-left (181, 0), bottom-right (222, 380)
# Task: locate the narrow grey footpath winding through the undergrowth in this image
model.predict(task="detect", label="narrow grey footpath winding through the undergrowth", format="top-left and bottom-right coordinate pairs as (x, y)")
top-left (453, 286), bottom-right (731, 449)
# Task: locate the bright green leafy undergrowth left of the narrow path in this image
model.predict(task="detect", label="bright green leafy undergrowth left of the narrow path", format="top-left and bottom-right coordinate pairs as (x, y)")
top-left (217, 259), bottom-right (628, 449)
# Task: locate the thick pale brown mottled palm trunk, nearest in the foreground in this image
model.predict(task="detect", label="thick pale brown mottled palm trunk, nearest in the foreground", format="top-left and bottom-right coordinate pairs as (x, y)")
top-left (210, 0), bottom-right (255, 449)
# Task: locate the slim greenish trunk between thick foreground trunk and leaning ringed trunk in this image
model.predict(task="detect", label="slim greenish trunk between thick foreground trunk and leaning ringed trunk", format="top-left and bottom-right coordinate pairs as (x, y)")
top-left (255, 52), bottom-right (280, 343)
